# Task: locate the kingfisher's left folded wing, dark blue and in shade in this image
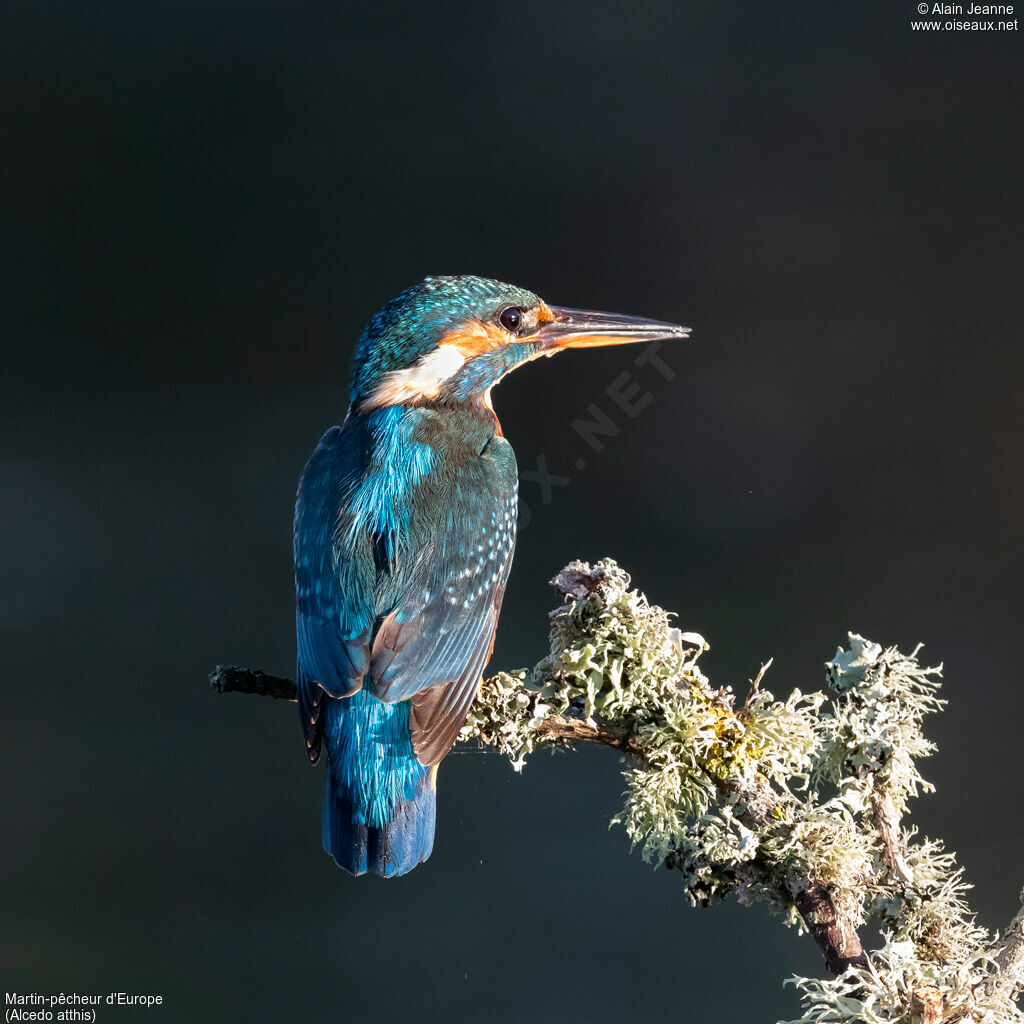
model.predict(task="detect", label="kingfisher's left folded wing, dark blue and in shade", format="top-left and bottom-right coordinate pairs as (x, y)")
top-left (294, 427), bottom-right (374, 763)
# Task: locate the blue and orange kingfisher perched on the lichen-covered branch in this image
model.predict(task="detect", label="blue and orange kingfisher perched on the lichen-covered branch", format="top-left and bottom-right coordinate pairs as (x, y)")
top-left (294, 275), bottom-right (689, 878)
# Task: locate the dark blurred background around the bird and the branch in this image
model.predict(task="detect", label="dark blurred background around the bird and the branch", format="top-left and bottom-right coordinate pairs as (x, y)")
top-left (0, 0), bottom-right (1024, 1024)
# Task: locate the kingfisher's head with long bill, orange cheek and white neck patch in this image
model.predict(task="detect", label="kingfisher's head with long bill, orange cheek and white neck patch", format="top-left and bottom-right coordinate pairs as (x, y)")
top-left (351, 275), bottom-right (689, 411)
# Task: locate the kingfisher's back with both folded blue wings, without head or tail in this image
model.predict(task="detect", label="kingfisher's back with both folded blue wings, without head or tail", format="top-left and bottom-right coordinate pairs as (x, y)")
top-left (295, 416), bottom-right (517, 764)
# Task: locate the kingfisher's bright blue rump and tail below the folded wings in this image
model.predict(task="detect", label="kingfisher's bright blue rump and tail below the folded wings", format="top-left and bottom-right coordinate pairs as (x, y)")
top-left (323, 690), bottom-right (437, 878)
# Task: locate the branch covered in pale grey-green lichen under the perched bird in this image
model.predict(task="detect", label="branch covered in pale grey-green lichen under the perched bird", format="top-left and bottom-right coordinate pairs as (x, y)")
top-left (211, 560), bottom-right (1024, 1024)
